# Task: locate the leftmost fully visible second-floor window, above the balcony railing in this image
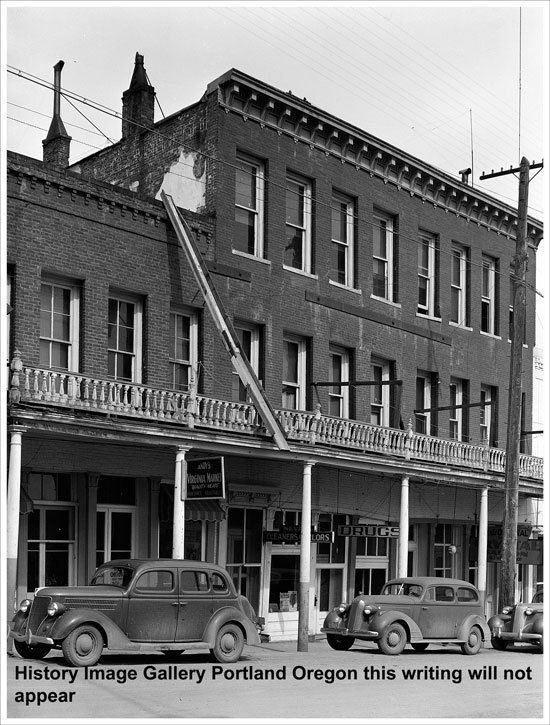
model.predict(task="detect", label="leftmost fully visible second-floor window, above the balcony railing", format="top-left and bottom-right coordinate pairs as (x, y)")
top-left (40, 280), bottom-right (80, 372)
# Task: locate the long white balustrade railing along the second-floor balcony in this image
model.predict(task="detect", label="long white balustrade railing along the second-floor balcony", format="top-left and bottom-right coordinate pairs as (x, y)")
top-left (10, 351), bottom-right (543, 480)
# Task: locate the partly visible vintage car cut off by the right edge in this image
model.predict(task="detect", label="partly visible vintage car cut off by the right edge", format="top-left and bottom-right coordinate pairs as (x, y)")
top-left (488, 587), bottom-right (544, 652)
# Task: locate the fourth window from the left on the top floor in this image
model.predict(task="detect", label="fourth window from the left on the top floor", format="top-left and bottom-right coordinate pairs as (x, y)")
top-left (372, 210), bottom-right (397, 302)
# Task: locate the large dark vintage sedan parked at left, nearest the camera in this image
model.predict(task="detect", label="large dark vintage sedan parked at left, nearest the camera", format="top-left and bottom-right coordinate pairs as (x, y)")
top-left (10, 559), bottom-right (263, 667)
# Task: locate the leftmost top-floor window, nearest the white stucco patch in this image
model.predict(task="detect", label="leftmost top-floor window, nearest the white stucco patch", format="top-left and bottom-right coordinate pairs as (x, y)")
top-left (233, 154), bottom-right (264, 257)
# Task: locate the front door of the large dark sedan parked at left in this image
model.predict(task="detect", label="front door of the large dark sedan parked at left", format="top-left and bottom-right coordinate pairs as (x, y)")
top-left (126, 568), bottom-right (179, 642)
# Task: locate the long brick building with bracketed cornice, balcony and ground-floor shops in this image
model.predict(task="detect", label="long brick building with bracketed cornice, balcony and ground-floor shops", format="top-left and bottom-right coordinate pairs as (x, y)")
top-left (7, 55), bottom-right (542, 638)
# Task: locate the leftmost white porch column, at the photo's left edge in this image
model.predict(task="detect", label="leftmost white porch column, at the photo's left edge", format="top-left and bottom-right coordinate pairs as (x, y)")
top-left (6, 425), bottom-right (25, 619)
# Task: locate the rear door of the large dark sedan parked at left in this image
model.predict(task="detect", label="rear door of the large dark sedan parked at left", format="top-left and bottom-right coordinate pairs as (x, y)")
top-left (176, 569), bottom-right (214, 642)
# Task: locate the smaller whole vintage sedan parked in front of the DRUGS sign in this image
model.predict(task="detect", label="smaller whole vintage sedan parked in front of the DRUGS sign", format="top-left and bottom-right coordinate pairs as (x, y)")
top-left (321, 577), bottom-right (490, 655)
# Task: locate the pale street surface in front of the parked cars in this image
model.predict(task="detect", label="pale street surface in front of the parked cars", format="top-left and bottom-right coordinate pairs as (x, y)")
top-left (7, 640), bottom-right (543, 720)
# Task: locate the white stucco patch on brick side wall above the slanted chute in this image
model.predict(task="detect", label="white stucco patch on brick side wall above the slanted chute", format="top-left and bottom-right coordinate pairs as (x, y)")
top-left (156, 150), bottom-right (206, 211)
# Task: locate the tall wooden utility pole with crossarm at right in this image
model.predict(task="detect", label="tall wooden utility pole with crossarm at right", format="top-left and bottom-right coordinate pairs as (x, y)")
top-left (480, 156), bottom-right (542, 611)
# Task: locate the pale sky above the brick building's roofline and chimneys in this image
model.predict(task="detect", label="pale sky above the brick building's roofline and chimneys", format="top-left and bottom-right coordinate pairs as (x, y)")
top-left (2, 0), bottom-right (549, 350)
